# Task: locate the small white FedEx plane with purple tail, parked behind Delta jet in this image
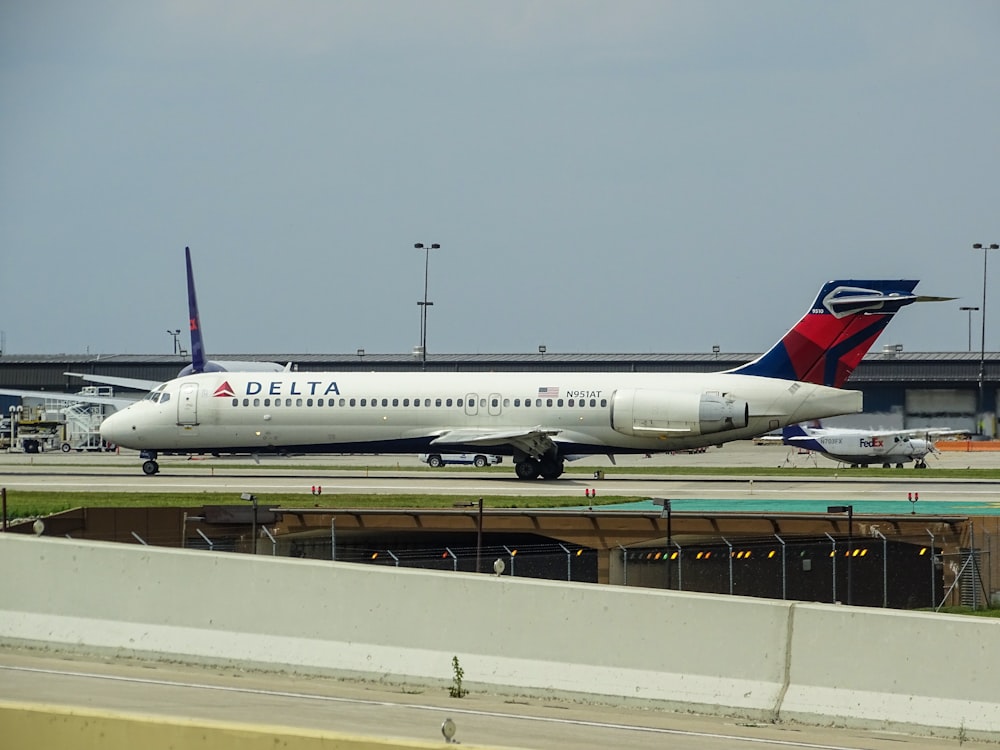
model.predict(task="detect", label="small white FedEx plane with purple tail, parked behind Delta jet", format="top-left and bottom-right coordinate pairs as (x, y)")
top-left (781, 425), bottom-right (962, 469)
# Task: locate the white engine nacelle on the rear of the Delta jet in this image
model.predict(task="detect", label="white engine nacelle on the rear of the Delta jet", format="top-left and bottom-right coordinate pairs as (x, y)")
top-left (611, 388), bottom-right (750, 437)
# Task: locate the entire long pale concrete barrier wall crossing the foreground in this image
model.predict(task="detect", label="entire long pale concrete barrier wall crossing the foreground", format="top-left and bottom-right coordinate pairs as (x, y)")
top-left (0, 535), bottom-right (1000, 732)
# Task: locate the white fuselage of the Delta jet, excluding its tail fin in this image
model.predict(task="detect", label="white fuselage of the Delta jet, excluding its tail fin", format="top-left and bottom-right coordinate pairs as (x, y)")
top-left (102, 372), bottom-right (861, 456)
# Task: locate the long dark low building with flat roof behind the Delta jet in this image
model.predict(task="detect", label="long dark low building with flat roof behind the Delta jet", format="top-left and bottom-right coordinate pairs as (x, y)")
top-left (0, 344), bottom-right (1000, 438)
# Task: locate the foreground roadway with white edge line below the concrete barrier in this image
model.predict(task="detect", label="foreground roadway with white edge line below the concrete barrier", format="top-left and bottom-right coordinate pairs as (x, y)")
top-left (0, 649), bottom-right (975, 750)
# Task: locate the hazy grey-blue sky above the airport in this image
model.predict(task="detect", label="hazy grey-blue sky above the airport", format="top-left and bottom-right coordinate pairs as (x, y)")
top-left (0, 0), bottom-right (1000, 354)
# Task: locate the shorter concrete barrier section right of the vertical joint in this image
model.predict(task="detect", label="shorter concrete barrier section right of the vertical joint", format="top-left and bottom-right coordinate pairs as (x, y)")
top-left (781, 604), bottom-right (1000, 739)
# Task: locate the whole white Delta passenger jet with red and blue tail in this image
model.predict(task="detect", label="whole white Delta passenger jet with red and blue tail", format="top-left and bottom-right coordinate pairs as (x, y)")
top-left (101, 280), bottom-right (940, 480)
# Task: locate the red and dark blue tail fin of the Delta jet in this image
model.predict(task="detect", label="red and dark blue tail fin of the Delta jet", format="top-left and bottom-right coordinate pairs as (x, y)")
top-left (729, 279), bottom-right (921, 388)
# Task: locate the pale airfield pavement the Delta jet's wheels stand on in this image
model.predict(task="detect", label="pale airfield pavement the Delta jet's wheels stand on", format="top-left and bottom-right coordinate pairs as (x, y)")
top-left (0, 443), bottom-right (1000, 515)
